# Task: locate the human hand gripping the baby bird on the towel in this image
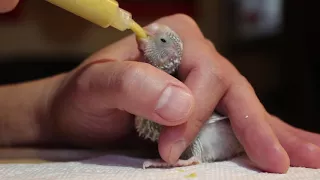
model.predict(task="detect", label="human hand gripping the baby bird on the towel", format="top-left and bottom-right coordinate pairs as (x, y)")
top-left (0, 1), bottom-right (320, 172)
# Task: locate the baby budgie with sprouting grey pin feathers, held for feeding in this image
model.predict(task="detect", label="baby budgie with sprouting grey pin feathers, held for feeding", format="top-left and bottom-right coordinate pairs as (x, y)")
top-left (135, 24), bottom-right (244, 168)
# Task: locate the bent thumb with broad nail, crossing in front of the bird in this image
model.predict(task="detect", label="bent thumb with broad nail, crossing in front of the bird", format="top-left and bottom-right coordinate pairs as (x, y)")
top-left (77, 61), bottom-right (194, 126)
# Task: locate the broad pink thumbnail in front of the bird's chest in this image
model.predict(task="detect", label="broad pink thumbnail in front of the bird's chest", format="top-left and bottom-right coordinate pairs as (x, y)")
top-left (155, 86), bottom-right (193, 121)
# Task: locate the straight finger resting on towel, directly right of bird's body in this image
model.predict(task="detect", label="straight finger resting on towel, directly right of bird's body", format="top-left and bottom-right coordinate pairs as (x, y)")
top-left (219, 76), bottom-right (290, 173)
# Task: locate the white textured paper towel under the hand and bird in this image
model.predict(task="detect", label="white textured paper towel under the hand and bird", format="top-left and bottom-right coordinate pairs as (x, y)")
top-left (0, 155), bottom-right (320, 180)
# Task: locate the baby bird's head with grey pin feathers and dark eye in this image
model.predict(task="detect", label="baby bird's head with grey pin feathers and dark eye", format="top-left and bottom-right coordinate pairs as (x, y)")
top-left (137, 24), bottom-right (183, 74)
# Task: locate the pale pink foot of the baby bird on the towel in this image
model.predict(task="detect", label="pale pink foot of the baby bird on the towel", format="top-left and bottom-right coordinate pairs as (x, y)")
top-left (143, 156), bottom-right (201, 169)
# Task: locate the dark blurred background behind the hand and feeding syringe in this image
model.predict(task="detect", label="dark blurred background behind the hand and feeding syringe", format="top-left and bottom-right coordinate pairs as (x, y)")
top-left (0, 0), bottom-right (320, 133)
